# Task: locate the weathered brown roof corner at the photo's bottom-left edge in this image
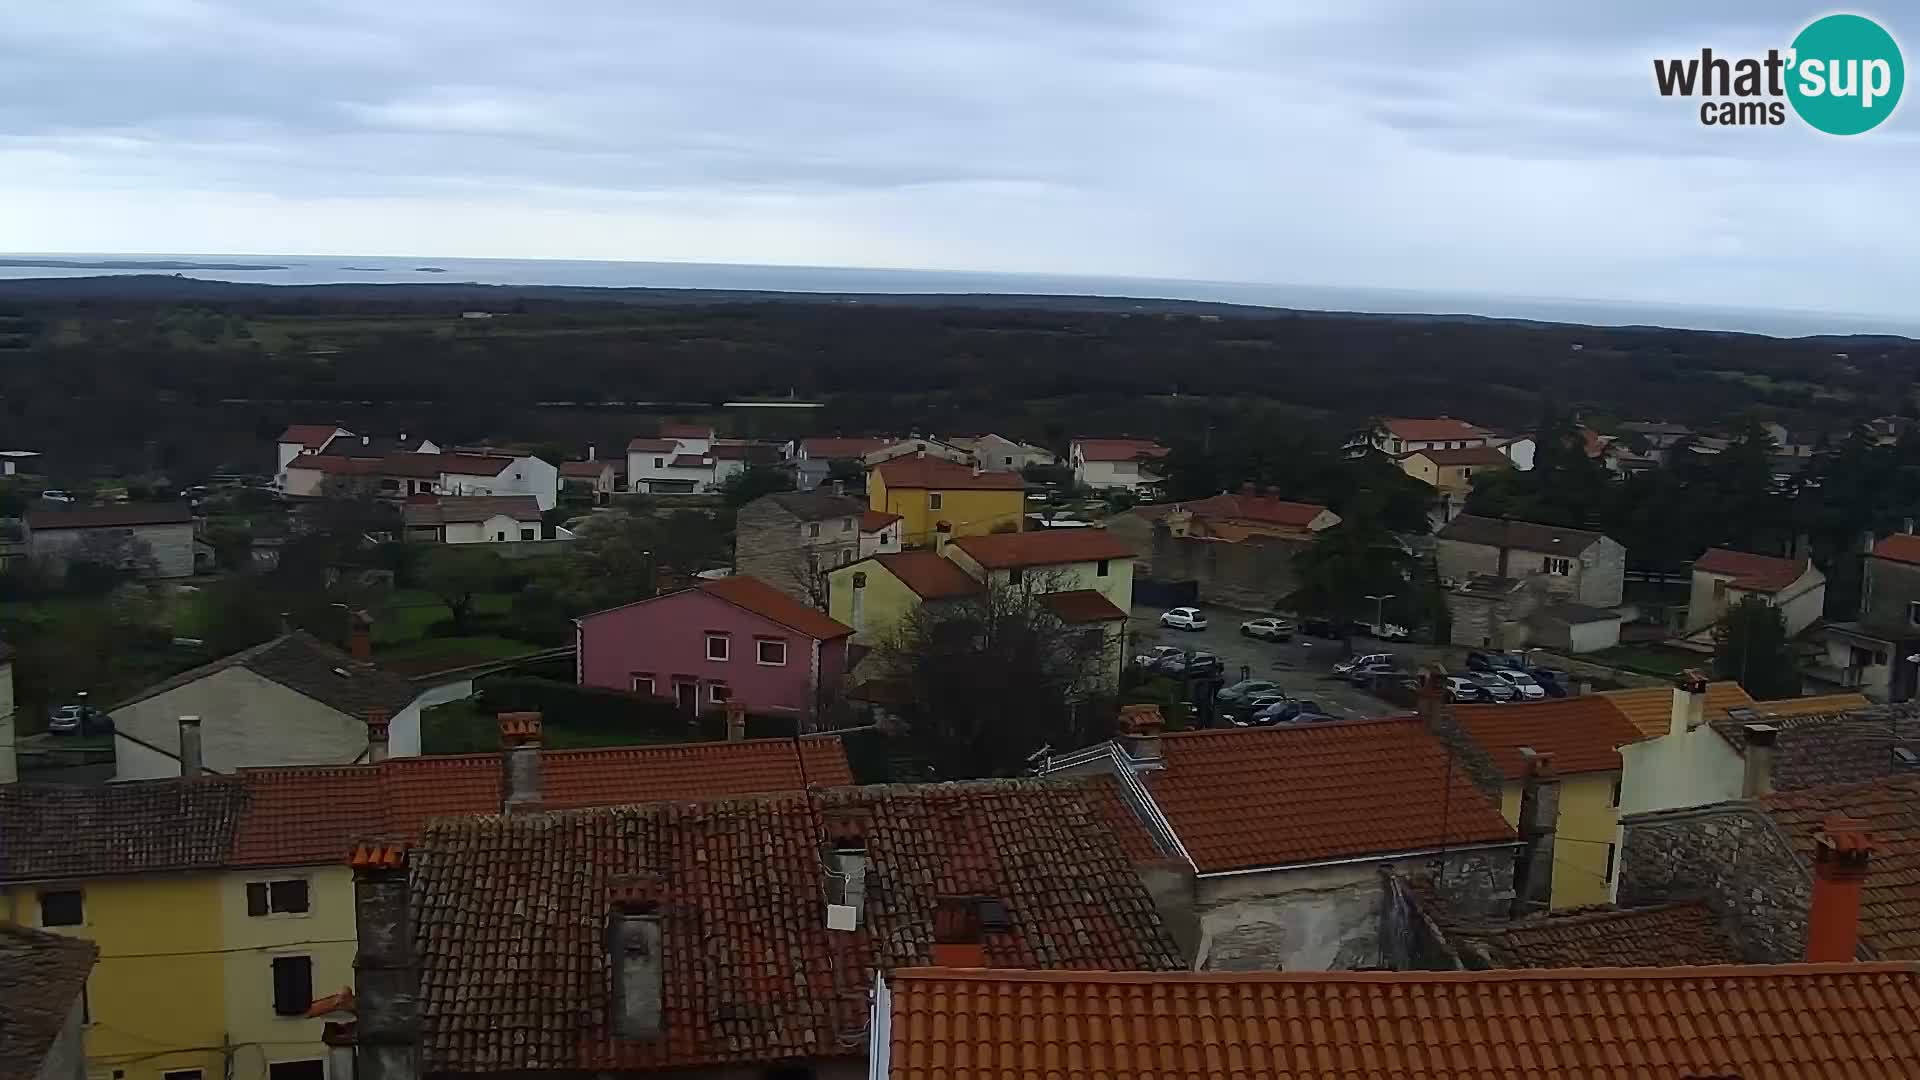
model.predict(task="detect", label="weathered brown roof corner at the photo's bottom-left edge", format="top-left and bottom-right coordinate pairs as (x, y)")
top-left (0, 922), bottom-right (100, 1080)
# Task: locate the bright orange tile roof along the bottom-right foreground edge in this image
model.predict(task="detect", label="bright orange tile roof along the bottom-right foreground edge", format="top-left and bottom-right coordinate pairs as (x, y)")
top-left (885, 965), bottom-right (1920, 1080)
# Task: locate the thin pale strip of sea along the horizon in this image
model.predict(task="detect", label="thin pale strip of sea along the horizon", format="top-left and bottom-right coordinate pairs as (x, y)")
top-left (0, 254), bottom-right (1920, 338)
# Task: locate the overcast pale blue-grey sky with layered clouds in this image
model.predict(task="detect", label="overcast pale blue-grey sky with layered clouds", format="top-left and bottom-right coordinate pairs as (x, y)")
top-left (0, 0), bottom-right (1920, 315)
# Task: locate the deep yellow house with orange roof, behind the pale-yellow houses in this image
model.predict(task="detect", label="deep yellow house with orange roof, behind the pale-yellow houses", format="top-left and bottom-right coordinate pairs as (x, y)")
top-left (866, 457), bottom-right (1027, 548)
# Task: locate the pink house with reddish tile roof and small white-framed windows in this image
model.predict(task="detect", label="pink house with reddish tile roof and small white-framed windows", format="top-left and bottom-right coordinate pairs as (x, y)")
top-left (574, 575), bottom-right (852, 719)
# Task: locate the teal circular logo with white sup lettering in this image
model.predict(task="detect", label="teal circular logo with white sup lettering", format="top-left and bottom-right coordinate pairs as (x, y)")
top-left (1788, 15), bottom-right (1907, 135)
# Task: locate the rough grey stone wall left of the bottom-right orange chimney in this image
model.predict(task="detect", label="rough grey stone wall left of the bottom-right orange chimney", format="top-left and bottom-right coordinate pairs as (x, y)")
top-left (1617, 803), bottom-right (1812, 963)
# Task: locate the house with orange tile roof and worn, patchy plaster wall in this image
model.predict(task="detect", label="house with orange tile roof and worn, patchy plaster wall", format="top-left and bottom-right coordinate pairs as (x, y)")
top-left (1041, 705), bottom-right (1520, 970)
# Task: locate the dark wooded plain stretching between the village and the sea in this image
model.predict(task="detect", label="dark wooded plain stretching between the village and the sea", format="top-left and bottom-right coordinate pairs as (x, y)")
top-left (0, 277), bottom-right (1920, 475)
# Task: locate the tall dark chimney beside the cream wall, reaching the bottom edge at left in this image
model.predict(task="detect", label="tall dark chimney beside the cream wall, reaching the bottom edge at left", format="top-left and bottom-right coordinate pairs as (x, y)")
top-left (348, 844), bottom-right (420, 1080)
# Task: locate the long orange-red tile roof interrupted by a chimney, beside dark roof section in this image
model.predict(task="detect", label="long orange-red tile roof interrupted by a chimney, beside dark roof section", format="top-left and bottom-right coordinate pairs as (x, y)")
top-left (232, 736), bottom-right (852, 867)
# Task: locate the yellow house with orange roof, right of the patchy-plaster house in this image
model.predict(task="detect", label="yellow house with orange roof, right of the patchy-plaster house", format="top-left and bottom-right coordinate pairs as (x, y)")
top-left (1453, 694), bottom-right (1642, 909)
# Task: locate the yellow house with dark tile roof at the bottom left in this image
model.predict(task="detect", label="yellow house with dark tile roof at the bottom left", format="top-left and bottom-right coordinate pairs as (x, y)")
top-left (0, 778), bottom-right (246, 1080)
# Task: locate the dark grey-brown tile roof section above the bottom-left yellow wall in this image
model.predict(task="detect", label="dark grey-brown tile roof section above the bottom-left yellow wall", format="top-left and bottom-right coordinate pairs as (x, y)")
top-left (0, 776), bottom-right (248, 882)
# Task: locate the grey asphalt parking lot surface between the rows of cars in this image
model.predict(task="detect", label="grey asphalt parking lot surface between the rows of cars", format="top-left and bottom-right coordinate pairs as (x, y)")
top-left (1127, 607), bottom-right (1440, 719)
